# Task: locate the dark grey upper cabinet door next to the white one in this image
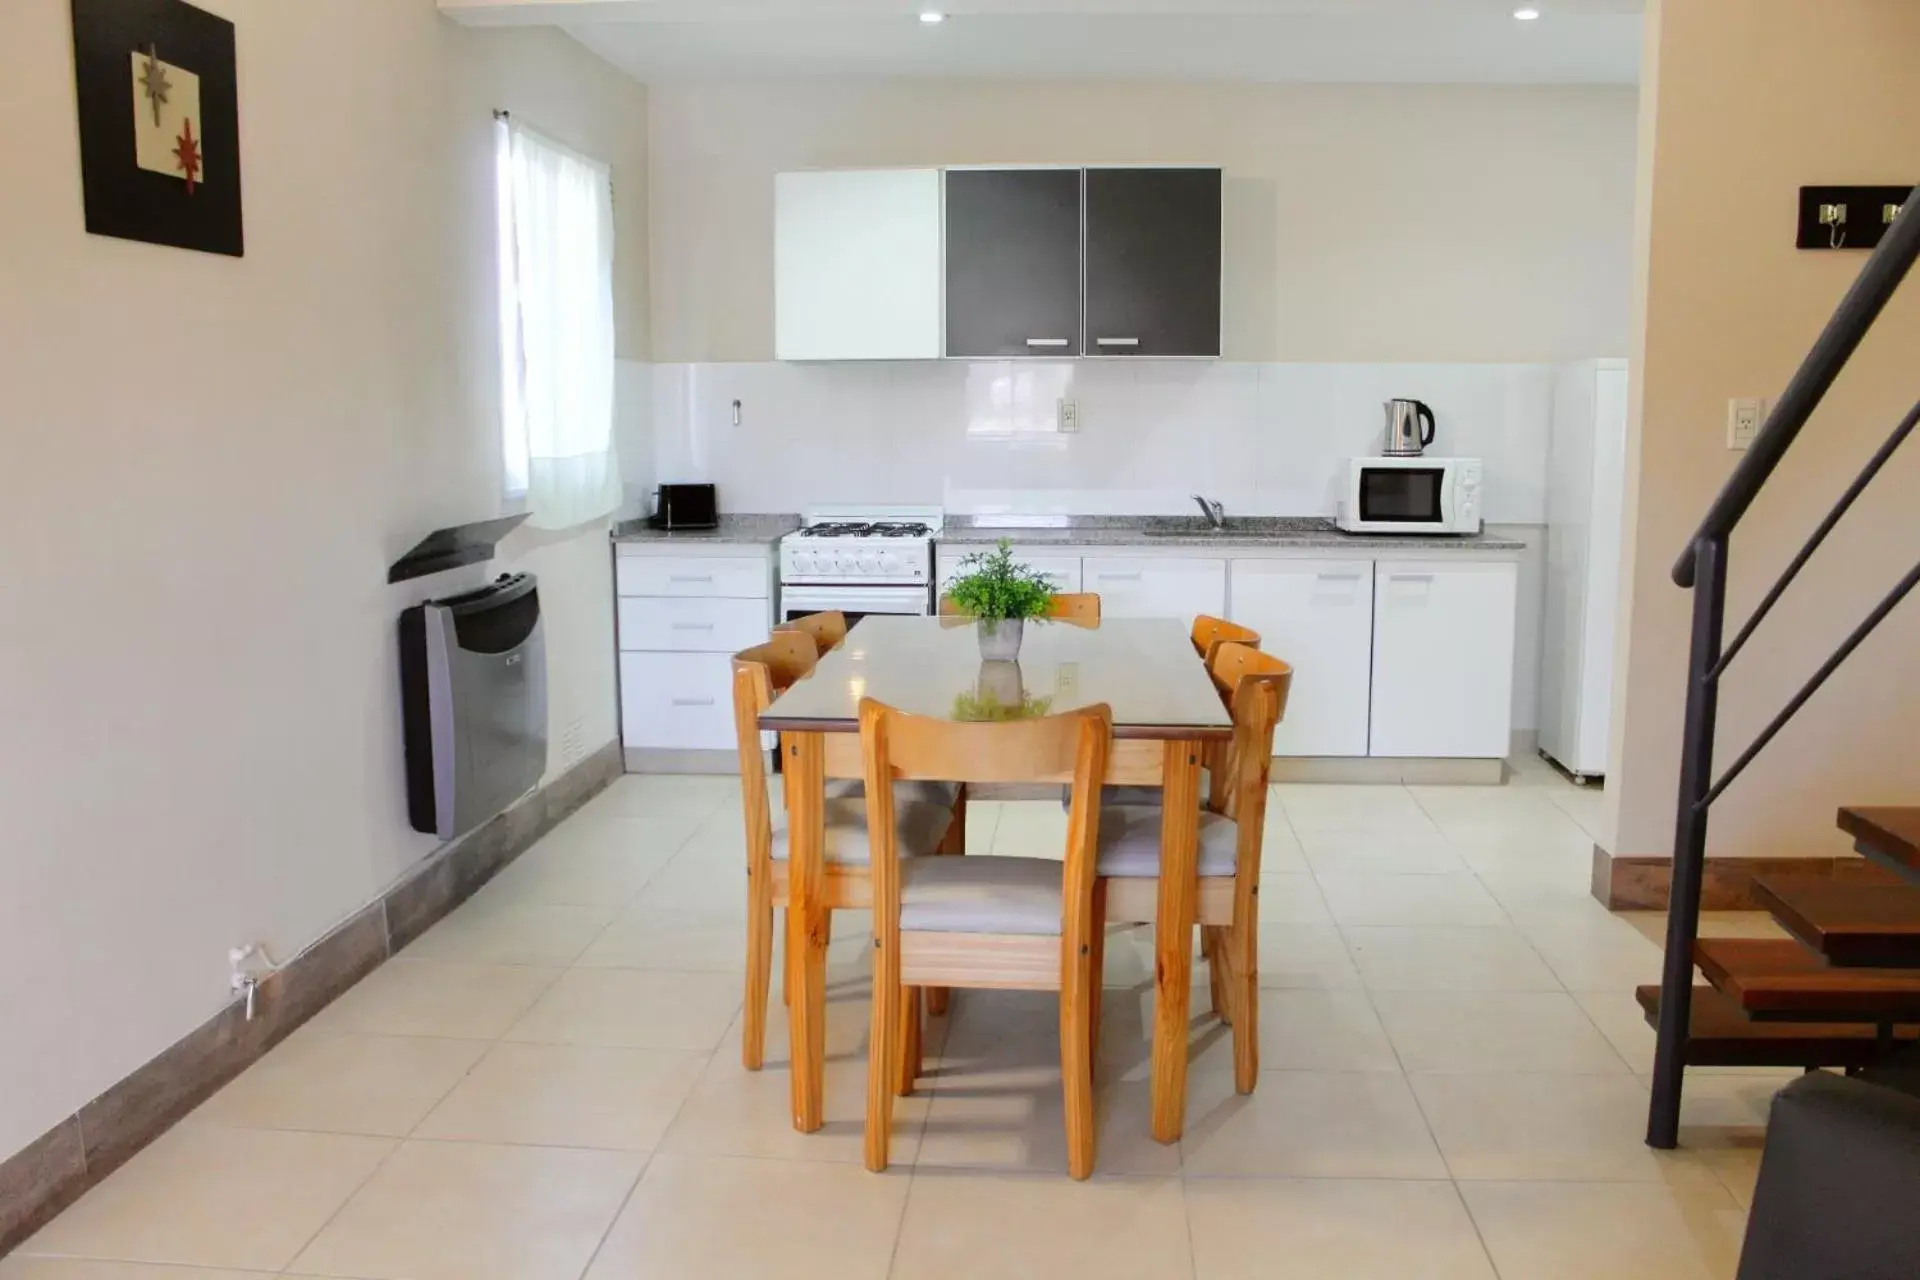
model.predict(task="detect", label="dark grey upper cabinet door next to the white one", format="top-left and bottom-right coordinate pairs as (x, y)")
top-left (947, 169), bottom-right (1081, 357)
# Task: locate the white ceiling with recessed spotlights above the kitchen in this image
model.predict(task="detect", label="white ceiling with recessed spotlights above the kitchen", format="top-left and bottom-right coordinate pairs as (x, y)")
top-left (442, 0), bottom-right (1644, 84)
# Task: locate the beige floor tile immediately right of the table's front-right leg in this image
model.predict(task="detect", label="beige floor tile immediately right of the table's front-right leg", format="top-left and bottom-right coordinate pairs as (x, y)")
top-left (1181, 1071), bottom-right (1448, 1178)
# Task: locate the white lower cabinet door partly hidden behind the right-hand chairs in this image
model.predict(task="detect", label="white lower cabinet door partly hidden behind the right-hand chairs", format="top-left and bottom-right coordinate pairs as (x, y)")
top-left (1233, 560), bottom-right (1373, 756)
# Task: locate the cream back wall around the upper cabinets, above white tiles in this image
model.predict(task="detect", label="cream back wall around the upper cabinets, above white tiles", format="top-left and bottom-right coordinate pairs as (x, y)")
top-left (649, 83), bottom-right (1636, 361)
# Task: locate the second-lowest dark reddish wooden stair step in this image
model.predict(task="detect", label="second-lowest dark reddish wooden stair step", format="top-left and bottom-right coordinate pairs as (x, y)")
top-left (1693, 938), bottom-right (1920, 1023)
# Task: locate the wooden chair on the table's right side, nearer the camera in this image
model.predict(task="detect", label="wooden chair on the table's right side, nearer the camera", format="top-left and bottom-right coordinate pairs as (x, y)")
top-left (1094, 643), bottom-right (1294, 1094)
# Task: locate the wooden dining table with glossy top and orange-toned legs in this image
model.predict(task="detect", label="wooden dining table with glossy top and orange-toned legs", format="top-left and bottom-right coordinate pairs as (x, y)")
top-left (760, 616), bottom-right (1233, 1142)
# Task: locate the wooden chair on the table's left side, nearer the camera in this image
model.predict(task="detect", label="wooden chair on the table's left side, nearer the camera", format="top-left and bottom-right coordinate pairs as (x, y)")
top-left (733, 631), bottom-right (954, 1071)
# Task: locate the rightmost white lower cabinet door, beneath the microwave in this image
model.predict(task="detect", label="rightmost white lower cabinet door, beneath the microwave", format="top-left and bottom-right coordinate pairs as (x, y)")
top-left (1374, 560), bottom-right (1519, 758)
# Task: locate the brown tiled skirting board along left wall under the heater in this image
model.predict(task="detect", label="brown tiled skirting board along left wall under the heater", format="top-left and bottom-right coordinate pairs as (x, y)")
top-left (0, 743), bottom-right (620, 1257)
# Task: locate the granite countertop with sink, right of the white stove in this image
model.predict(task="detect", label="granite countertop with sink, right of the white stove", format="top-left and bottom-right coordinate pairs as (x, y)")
top-left (939, 516), bottom-right (1526, 551)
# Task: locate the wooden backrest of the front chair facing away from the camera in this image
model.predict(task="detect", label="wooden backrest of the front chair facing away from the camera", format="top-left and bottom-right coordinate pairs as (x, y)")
top-left (860, 699), bottom-right (1114, 929)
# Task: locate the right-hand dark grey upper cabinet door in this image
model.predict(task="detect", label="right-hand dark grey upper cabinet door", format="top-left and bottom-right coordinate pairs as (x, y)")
top-left (1090, 169), bottom-right (1221, 355)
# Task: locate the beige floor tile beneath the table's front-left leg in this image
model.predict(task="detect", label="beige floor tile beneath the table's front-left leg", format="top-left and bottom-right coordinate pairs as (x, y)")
top-left (660, 986), bottom-right (945, 1167)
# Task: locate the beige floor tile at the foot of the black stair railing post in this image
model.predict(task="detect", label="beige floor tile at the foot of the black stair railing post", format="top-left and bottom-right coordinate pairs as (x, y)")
top-left (1411, 1075), bottom-right (1713, 1184)
